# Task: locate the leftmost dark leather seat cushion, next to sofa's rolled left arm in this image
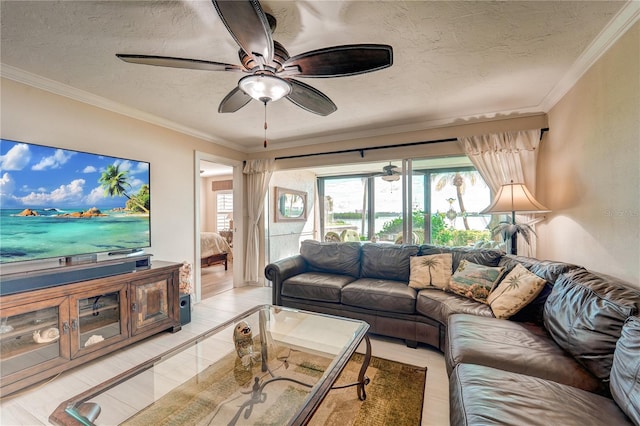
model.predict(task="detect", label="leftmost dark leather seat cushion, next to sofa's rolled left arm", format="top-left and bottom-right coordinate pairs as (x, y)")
top-left (281, 272), bottom-right (355, 303)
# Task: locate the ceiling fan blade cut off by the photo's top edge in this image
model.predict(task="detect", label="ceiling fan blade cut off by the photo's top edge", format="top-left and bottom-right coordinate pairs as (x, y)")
top-left (212, 0), bottom-right (273, 63)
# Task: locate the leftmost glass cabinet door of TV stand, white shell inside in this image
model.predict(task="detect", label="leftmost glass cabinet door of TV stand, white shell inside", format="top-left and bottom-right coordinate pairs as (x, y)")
top-left (0, 297), bottom-right (69, 383)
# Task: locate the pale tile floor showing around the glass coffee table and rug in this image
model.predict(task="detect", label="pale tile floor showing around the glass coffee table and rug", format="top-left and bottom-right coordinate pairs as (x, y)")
top-left (0, 287), bottom-right (449, 426)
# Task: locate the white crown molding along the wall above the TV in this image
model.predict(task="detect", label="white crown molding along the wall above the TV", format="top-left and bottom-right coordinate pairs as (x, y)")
top-left (0, 64), bottom-right (245, 152)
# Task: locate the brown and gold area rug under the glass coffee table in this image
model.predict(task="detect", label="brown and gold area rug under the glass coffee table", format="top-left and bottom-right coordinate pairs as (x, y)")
top-left (123, 352), bottom-right (427, 426)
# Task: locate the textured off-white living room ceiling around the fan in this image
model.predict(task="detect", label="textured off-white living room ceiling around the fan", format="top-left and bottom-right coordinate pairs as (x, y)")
top-left (0, 0), bottom-right (639, 152)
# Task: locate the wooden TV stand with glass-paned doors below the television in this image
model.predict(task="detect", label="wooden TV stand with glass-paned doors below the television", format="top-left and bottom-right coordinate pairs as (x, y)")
top-left (0, 261), bottom-right (181, 396)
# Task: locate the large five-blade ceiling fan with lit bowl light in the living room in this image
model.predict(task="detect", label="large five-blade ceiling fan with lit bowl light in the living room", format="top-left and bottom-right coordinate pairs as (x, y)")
top-left (116, 0), bottom-right (393, 116)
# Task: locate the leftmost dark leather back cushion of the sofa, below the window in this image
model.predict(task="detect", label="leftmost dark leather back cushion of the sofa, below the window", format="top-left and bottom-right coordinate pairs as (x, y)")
top-left (300, 240), bottom-right (360, 278)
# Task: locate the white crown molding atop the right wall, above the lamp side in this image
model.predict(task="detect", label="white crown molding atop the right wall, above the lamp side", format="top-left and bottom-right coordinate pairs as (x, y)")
top-left (540, 0), bottom-right (640, 112)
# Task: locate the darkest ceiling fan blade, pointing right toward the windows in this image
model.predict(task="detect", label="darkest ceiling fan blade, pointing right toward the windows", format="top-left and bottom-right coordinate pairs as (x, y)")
top-left (284, 44), bottom-right (393, 77)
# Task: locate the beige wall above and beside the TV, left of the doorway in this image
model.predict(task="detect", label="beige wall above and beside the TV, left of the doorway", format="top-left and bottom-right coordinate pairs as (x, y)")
top-left (1, 79), bottom-right (242, 270)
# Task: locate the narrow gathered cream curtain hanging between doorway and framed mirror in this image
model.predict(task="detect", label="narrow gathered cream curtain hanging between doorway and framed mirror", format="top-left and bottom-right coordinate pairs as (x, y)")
top-left (243, 159), bottom-right (275, 282)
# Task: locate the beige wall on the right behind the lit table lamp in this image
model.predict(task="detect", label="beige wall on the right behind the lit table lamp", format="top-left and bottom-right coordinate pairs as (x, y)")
top-left (536, 23), bottom-right (640, 287)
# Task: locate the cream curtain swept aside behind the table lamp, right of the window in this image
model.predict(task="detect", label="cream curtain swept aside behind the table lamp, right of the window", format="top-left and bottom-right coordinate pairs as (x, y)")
top-left (458, 129), bottom-right (540, 257)
